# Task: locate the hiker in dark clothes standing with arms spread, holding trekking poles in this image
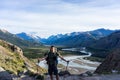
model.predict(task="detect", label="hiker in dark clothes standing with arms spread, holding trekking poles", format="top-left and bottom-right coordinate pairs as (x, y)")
top-left (39, 46), bottom-right (69, 80)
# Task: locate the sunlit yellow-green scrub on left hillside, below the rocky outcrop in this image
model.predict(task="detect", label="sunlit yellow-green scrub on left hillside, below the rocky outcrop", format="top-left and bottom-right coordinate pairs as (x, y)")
top-left (0, 48), bottom-right (26, 75)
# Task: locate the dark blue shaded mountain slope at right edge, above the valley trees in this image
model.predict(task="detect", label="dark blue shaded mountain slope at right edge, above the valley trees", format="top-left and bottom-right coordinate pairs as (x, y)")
top-left (92, 31), bottom-right (120, 49)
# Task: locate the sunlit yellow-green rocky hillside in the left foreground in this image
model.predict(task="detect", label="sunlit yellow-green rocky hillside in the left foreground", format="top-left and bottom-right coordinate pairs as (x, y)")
top-left (0, 40), bottom-right (45, 80)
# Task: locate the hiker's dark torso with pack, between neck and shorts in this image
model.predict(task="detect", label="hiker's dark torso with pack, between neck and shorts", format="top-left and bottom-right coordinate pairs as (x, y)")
top-left (46, 52), bottom-right (59, 65)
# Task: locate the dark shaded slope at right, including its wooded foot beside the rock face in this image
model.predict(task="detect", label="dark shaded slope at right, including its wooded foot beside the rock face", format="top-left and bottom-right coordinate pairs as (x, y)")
top-left (89, 31), bottom-right (120, 58)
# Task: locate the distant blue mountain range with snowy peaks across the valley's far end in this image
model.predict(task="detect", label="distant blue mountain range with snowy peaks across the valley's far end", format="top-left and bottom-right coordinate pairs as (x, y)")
top-left (16, 28), bottom-right (116, 47)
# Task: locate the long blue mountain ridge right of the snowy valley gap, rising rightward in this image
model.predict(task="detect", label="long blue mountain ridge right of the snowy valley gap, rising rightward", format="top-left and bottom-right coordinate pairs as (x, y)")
top-left (41, 29), bottom-right (114, 47)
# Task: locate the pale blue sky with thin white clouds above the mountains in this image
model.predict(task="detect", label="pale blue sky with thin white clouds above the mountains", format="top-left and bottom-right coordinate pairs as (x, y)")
top-left (0, 0), bottom-right (120, 37)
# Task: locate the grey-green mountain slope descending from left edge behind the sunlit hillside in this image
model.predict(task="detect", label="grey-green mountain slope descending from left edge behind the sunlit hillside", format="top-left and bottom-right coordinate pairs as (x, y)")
top-left (0, 29), bottom-right (41, 47)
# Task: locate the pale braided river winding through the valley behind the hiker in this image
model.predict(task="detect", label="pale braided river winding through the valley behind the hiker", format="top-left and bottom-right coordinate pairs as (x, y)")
top-left (39, 48), bottom-right (100, 74)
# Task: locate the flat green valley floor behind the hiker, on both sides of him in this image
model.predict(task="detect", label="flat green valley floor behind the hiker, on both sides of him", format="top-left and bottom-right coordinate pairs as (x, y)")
top-left (23, 46), bottom-right (83, 59)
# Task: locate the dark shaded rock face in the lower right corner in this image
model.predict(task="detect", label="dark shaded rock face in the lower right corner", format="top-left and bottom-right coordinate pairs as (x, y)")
top-left (95, 48), bottom-right (120, 74)
